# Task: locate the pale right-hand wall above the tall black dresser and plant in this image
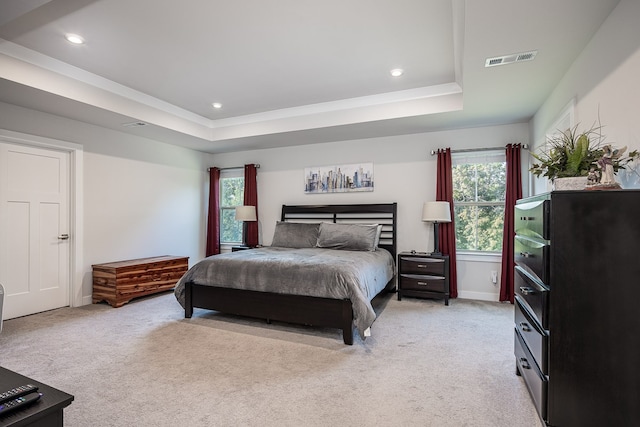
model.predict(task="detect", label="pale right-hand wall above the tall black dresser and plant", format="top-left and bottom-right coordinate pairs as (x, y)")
top-left (531, 0), bottom-right (640, 194)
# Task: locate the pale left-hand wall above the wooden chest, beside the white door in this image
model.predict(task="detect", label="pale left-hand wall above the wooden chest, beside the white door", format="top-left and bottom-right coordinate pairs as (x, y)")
top-left (0, 103), bottom-right (208, 304)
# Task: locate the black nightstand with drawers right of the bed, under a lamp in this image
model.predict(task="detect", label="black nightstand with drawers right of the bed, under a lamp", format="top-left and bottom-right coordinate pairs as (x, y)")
top-left (398, 252), bottom-right (449, 305)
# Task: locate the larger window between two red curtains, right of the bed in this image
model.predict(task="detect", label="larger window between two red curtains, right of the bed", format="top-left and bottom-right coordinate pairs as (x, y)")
top-left (451, 151), bottom-right (507, 252)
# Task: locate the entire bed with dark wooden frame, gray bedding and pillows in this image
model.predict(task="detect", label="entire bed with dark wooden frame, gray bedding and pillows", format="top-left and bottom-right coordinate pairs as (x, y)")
top-left (175, 203), bottom-right (397, 345)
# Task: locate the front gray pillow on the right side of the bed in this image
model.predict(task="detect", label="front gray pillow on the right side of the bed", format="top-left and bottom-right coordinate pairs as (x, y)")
top-left (318, 222), bottom-right (382, 251)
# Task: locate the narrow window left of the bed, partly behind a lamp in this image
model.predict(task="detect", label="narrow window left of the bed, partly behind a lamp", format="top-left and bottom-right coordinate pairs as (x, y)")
top-left (220, 168), bottom-right (244, 244)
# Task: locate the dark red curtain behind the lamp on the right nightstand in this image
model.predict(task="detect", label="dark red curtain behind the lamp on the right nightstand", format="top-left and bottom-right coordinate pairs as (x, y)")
top-left (436, 148), bottom-right (458, 298)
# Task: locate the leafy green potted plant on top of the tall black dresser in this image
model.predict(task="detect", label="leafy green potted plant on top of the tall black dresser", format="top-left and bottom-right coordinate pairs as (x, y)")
top-left (529, 125), bottom-right (639, 190)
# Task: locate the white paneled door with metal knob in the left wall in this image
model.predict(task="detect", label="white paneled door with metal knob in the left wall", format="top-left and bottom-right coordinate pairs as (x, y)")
top-left (0, 141), bottom-right (70, 319)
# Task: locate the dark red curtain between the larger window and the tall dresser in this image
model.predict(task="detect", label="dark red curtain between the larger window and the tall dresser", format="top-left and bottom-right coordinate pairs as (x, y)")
top-left (500, 144), bottom-right (522, 304)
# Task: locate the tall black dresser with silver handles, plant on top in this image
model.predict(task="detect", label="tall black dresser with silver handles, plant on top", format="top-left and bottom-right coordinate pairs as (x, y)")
top-left (514, 190), bottom-right (640, 427)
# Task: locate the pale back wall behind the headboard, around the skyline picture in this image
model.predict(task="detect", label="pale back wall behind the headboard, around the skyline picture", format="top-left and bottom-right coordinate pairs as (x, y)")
top-left (210, 124), bottom-right (528, 301)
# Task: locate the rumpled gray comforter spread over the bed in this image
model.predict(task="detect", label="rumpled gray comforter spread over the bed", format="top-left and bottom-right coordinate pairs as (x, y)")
top-left (175, 247), bottom-right (395, 335)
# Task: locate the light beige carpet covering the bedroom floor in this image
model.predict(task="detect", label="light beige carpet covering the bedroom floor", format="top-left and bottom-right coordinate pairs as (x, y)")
top-left (0, 293), bottom-right (541, 427)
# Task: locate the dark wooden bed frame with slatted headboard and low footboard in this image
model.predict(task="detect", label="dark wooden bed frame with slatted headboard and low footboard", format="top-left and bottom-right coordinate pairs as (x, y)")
top-left (185, 203), bottom-right (397, 345)
